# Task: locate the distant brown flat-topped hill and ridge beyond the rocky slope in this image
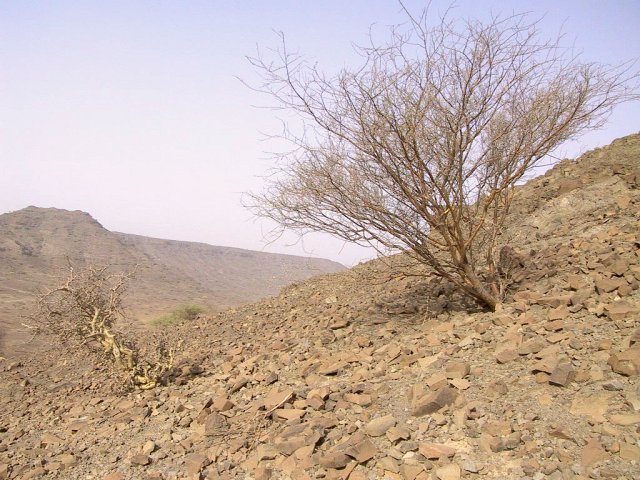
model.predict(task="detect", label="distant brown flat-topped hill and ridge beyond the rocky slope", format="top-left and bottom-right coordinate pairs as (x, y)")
top-left (0, 207), bottom-right (344, 356)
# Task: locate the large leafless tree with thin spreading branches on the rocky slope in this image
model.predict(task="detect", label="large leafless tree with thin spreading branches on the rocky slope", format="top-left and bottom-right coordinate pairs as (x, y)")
top-left (247, 5), bottom-right (638, 308)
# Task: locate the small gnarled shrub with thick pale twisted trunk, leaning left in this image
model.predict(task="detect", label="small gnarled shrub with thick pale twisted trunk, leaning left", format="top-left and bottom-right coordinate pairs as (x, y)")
top-left (38, 265), bottom-right (176, 390)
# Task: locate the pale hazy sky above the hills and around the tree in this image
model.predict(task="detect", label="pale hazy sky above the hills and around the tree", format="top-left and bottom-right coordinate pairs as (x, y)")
top-left (0, 0), bottom-right (640, 264)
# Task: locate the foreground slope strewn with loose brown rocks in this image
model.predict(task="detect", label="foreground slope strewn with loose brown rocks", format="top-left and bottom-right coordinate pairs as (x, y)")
top-left (0, 135), bottom-right (640, 480)
